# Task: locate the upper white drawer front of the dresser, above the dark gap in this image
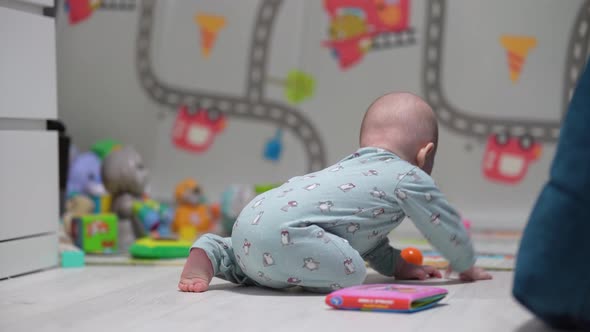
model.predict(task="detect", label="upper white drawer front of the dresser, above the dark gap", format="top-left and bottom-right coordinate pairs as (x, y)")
top-left (0, 6), bottom-right (57, 119)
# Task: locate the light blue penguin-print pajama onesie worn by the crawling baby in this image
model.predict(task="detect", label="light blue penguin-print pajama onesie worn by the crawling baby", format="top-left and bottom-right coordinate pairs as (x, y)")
top-left (193, 148), bottom-right (475, 292)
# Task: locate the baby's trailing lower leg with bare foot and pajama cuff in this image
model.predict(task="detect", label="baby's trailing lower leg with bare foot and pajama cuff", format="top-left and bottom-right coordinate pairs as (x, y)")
top-left (178, 234), bottom-right (252, 292)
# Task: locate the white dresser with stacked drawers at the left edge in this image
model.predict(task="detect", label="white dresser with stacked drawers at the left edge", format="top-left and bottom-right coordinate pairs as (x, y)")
top-left (0, 0), bottom-right (59, 279)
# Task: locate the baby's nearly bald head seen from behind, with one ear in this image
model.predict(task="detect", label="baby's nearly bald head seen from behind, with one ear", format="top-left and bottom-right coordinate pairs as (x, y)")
top-left (360, 92), bottom-right (438, 174)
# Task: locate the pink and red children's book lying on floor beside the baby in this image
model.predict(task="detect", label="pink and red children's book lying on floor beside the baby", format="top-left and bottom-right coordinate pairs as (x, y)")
top-left (326, 284), bottom-right (448, 313)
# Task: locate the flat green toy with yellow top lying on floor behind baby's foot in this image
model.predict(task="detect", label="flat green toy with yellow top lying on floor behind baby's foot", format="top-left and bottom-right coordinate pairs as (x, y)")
top-left (129, 237), bottom-right (193, 259)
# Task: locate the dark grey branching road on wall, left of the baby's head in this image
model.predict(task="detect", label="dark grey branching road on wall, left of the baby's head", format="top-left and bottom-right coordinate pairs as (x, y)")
top-left (136, 0), bottom-right (326, 171)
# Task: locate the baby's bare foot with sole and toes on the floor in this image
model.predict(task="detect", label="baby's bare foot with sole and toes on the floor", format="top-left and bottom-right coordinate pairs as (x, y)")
top-left (178, 248), bottom-right (213, 292)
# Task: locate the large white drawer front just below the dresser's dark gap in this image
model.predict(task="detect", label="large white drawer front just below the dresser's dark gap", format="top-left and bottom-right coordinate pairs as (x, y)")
top-left (0, 130), bottom-right (59, 241)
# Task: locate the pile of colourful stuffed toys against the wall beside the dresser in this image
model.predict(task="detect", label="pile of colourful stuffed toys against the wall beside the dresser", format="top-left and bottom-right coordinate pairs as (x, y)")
top-left (62, 139), bottom-right (234, 253)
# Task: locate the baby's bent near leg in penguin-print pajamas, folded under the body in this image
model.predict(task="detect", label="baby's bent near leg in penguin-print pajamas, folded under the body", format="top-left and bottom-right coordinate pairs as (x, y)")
top-left (236, 225), bottom-right (366, 292)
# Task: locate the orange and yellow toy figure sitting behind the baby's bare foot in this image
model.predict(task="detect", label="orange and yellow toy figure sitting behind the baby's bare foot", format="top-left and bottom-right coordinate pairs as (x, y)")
top-left (172, 179), bottom-right (219, 241)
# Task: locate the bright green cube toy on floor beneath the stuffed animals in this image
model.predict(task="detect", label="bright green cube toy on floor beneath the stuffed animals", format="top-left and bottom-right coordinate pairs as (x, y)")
top-left (72, 213), bottom-right (119, 254)
